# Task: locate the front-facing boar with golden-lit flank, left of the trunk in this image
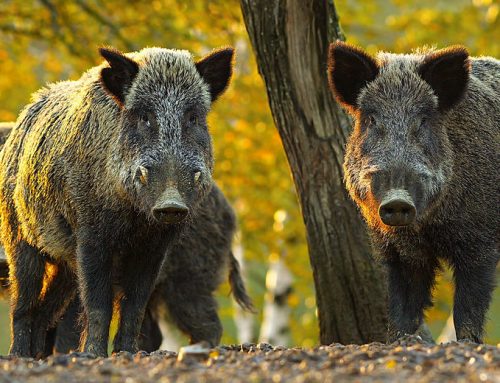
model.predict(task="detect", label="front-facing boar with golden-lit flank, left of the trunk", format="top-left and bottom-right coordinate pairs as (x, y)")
top-left (0, 48), bottom-right (233, 356)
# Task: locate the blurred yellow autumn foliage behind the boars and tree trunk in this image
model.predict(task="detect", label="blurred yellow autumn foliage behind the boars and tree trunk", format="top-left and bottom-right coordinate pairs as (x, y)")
top-left (0, 0), bottom-right (500, 354)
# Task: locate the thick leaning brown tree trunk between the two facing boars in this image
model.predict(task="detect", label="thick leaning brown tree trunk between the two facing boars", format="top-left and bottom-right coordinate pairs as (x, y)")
top-left (241, 0), bottom-right (386, 344)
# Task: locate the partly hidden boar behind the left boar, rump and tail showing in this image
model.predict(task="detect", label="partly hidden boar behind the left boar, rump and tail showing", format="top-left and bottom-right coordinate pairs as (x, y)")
top-left (47, 185), bottom-right (252, 353)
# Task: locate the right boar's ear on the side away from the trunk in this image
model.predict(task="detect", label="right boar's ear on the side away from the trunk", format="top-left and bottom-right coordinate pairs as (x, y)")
top-left (419, 46), bottom-right (470, 111)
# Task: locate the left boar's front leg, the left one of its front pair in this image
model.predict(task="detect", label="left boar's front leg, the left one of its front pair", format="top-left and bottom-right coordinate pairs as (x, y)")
top-left (77, 236), bottom-right (113, 357)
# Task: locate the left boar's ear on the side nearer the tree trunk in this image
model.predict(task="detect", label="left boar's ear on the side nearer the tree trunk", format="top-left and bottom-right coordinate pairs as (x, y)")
top-left (195, 48), bottom-right (234, 102)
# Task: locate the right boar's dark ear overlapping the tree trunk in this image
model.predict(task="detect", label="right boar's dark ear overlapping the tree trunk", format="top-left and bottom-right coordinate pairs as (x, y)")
top-left (328, 41), bottom-right (379, 111)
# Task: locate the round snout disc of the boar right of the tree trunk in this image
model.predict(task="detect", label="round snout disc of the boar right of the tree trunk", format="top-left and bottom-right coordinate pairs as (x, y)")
top-left (378, 190), bottom-right (417, 226)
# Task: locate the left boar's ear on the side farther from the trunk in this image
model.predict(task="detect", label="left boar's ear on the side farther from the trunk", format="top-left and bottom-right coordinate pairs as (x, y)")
top-left (99, 48), bottom-right (139, 105)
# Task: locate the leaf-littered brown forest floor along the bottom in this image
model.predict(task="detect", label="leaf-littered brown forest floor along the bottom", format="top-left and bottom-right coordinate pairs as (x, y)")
top-left (0, 337), bottom-right (500, 383)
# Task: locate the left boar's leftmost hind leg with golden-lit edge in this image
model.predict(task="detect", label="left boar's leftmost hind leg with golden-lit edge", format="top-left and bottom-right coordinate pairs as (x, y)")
top-left (9, 241), bottom-right (45, 357)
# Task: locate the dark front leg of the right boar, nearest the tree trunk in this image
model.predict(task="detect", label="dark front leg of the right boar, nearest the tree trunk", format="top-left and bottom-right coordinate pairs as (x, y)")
top-left (388, 258), bottom-right (438, 342)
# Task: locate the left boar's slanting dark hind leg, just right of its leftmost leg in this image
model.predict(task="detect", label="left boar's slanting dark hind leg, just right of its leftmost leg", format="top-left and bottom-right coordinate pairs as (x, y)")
top-left (31, 264), bottom-right (76, 357)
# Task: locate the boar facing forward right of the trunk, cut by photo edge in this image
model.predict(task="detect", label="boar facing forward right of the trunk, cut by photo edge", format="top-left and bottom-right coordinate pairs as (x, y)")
top-left (329, 42), bottom-right (500, 342)
